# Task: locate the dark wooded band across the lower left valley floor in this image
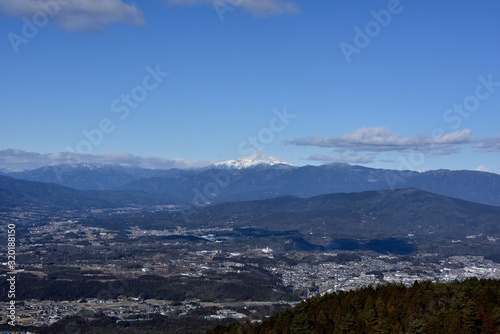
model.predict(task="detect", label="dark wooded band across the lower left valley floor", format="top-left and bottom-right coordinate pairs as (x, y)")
top-left (0, 266), bottom-right (297, 301)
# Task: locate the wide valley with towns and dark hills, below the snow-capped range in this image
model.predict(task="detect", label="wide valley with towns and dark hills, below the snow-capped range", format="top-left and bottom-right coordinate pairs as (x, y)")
top-left (0, 162), bottom-right (500, 333)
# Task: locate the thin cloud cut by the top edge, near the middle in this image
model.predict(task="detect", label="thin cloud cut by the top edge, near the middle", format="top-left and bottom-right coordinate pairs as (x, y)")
top-left (166, 0), bottom-right (300, 16)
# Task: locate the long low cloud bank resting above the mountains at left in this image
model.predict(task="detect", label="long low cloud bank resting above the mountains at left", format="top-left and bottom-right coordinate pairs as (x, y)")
top-left (0, 149), bottom-right (209, 169)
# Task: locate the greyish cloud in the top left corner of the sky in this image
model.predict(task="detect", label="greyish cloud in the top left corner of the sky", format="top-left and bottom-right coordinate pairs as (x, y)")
top-left (0, 0), bottom-right (144, 31)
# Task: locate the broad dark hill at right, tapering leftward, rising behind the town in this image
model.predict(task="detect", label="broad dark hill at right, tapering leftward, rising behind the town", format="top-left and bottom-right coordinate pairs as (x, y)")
top-left (79, 189), bottom-right (500, 255)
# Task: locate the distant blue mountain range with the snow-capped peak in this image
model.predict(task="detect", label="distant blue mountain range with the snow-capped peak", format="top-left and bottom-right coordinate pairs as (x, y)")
top-left (0, 160), bottom-right (500, 206)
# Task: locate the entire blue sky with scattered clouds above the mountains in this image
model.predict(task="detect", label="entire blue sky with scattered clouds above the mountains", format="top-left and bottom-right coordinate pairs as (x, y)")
top-left (0, 0), bottom-right (500, 172)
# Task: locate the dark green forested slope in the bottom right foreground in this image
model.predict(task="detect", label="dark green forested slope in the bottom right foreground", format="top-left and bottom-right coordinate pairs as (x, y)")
top-left (207, 279), bottom-right (500, 334)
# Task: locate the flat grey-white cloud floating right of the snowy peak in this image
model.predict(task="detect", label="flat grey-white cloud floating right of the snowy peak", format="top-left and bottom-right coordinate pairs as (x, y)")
top-left (286, 127), bottom-right (474, 155)
